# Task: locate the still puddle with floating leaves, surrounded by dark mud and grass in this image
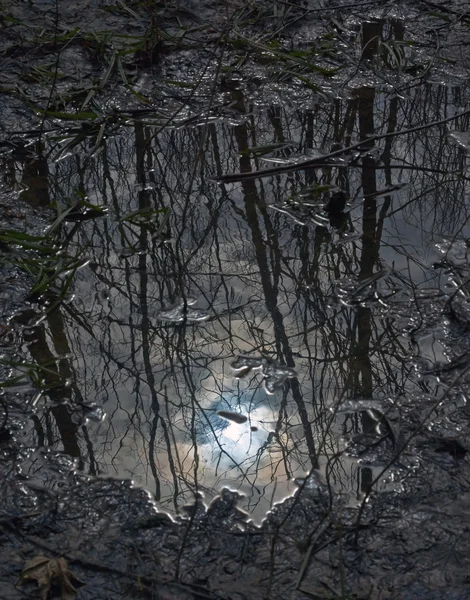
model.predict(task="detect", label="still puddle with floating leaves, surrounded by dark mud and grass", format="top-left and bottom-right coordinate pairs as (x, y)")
top-left (1, 74), bottom-right (467, 522)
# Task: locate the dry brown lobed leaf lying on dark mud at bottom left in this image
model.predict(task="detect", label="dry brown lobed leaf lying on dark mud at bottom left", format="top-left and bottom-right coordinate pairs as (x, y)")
top-left (21, 556), bottom-right (81, 600)
